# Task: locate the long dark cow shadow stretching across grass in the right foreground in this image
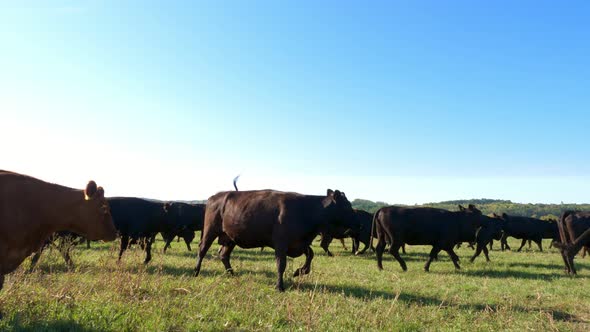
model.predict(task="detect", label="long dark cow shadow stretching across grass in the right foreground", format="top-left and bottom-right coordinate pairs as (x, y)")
top-left (290, 281), bottom-right (584, 322)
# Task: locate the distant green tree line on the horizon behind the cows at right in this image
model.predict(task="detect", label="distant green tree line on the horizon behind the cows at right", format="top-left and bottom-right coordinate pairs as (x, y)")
top-left (352, 199), bottom-right (590, 219)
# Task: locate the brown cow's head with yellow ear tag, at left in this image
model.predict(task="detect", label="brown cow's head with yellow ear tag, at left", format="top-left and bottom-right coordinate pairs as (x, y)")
top-left (76, 181), bottom-right (117, 241)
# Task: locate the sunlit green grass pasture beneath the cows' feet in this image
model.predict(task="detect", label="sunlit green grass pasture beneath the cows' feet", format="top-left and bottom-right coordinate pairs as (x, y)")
top-left (0, 237), bottom-right (590, 331)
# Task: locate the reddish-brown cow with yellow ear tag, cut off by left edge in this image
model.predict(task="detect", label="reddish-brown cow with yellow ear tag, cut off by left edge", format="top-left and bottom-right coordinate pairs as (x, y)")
top-left (0, 170), bottom-right (117, 316)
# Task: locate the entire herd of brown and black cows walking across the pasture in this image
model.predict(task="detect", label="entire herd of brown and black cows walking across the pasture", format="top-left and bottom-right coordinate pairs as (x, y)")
top-left (0, 170), bottom-right (590, 317)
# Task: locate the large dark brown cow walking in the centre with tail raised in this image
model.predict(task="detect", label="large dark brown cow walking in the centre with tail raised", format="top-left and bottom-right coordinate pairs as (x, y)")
top-left (194, 189), bottom-right (354, 292)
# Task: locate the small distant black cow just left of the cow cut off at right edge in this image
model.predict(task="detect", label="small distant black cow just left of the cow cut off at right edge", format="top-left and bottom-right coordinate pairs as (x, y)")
top-left (494, 213), bottom-right (559, 252)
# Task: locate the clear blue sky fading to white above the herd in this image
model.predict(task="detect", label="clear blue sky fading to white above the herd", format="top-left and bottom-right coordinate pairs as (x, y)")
top-left (0, 0), bottom-right (590, 204)
